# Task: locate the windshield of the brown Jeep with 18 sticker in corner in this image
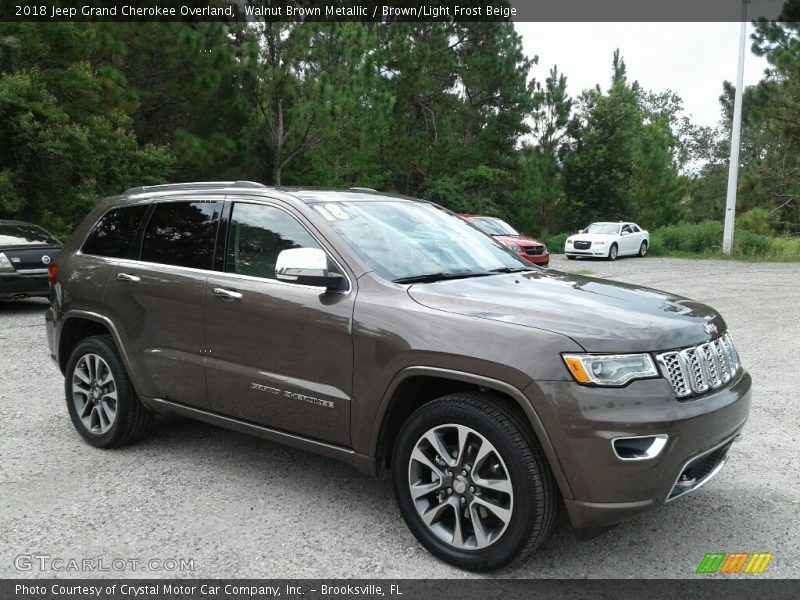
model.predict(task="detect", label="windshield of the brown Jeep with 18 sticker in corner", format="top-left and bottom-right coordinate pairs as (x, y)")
top-left (311, 201), bottom-right (531, 281)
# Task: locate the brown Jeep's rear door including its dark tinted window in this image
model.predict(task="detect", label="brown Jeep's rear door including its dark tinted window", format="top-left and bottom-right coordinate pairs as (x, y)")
top-left (104, 197), bottom-right (222, 408)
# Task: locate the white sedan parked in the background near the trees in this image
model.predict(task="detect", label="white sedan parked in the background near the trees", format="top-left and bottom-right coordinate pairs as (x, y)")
top-left (564, 222), bottom-right (650, 260)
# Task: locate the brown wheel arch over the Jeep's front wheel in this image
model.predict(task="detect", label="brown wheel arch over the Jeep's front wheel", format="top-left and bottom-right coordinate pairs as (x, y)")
top-left (369, 367), bottom-right (572, 498)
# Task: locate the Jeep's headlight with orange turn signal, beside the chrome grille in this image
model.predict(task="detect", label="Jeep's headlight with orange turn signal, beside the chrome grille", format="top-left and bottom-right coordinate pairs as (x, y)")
top-left (564, 354), bottom-right (658, 385)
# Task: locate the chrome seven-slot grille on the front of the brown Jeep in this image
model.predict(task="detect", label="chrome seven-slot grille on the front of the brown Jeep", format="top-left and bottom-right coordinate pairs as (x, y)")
top-left (656, 333), bottom-right (739, 398)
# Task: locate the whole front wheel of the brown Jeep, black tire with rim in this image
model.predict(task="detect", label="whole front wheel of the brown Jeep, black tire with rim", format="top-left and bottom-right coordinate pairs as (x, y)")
top-left (392, 393), bottom-right (558, 571)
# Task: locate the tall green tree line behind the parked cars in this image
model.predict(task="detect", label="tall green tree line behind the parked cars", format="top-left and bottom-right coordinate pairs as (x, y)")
top-left (0, 14), bottom-right (800, 235)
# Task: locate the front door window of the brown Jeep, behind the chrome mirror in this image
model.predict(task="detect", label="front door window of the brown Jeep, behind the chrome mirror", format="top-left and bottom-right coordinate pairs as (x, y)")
top-left (225, 203), bottom-right (320, 279)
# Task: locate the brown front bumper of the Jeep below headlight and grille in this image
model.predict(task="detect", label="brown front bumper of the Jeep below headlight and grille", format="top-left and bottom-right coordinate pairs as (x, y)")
top-left (526, 369), bottom-right (751, 528)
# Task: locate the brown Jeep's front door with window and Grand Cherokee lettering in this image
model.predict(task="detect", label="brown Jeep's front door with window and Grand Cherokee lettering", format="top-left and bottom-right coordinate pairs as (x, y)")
top-left (205, 201), bottom-right (355, 446)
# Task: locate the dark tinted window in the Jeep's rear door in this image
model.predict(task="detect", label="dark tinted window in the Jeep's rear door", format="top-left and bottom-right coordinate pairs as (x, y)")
top-left (141, 202), bottom-right (218, 269)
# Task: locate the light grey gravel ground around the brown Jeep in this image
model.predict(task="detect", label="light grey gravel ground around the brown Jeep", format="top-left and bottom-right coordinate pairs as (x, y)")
top-left (0, 256), bottom-right (800, 578)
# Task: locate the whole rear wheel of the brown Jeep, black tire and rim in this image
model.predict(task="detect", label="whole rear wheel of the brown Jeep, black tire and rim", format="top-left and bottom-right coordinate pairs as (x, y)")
top-left (64, 335), bottom-right (154, 448)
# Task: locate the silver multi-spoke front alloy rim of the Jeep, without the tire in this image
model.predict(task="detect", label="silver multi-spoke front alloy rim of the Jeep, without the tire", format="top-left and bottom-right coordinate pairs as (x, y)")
top-left (408, 424), bottom-right (514, 550)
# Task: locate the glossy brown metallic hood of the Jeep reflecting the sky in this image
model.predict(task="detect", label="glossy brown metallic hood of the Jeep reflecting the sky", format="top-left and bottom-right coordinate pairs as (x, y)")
top-left (408, 270), bottom-right (726, 352)
